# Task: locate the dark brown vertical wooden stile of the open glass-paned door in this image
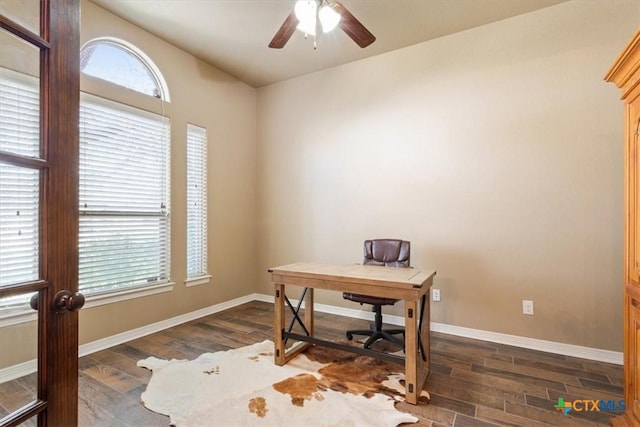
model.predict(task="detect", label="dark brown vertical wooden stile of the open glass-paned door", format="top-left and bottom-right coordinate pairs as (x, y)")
top-left (38, 0), bottom-right (80, 426)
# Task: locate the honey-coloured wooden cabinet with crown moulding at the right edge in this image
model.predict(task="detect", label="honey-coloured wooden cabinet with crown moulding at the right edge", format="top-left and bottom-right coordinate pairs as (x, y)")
top-left (605, 31), bottom-right (640, 426)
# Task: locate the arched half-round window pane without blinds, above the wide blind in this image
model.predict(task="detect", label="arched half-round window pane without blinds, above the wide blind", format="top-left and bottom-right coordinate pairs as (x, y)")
top-left (80, 37), bottom-right (169, 101)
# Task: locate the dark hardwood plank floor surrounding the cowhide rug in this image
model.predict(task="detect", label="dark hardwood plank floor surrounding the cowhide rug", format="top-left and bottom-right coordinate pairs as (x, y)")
top-left (0, 302), bottom-right (623, 427)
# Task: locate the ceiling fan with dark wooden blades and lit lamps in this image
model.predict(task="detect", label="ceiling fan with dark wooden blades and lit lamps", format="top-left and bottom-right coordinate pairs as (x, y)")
top-left (269, 0), bottom-right (376, 49)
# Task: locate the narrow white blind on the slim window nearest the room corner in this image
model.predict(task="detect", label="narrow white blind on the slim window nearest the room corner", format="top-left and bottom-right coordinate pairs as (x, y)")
top-left (187, 124), bottom-right (208, 279)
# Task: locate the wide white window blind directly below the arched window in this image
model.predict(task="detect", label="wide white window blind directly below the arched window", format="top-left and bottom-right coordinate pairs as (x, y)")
top-left (79, 94), bottom-right (170, 294)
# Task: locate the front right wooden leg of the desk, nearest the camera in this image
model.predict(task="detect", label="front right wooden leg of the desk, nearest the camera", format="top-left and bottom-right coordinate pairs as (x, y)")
top-left (404, 301), bottom-right (422, 405)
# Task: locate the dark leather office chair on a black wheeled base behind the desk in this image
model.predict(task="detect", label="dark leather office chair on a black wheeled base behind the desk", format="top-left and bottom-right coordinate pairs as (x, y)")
top-left (342, 239), bottom-right (411, 349)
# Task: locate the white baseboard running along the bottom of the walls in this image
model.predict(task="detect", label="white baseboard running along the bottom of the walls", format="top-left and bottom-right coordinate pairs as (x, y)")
top-left (0, 293), bottom-right (623, 384)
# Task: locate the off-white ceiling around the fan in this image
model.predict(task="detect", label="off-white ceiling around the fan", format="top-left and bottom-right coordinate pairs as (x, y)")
top-left (91, 0), bottom-right (567, 87)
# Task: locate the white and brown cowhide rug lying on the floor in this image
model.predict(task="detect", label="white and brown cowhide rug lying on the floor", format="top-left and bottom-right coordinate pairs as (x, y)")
top-left (138, 341), bottom-right (428, 427)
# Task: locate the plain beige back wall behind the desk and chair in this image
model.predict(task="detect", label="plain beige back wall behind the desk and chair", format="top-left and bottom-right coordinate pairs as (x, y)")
top-left (257, 1), bottom-right (640, 351)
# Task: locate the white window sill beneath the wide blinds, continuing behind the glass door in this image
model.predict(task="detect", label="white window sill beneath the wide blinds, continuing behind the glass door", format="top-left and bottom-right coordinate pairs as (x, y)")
top-left (0, 282), bottom-right (175, 328)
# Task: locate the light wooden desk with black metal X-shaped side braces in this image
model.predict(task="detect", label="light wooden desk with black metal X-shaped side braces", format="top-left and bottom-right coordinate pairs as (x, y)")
top-left (269, 263), bottom-right (436, 405)
